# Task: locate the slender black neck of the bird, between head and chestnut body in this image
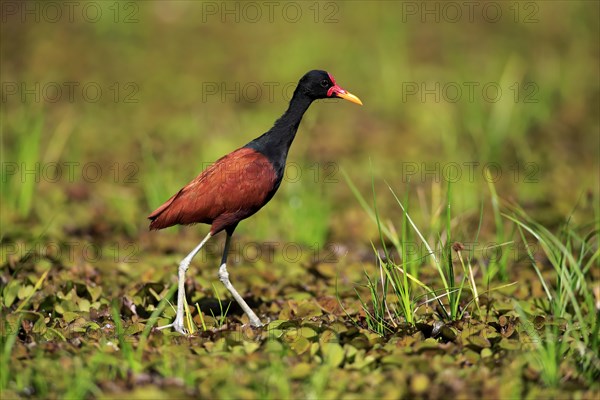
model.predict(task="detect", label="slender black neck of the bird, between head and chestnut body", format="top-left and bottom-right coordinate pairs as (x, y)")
top-left (244, 88), bottom-right (313, 182)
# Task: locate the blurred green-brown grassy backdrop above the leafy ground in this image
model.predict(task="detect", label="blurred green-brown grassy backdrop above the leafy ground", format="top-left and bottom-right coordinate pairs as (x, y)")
top-left (1, 1), bottom-right (600, 247)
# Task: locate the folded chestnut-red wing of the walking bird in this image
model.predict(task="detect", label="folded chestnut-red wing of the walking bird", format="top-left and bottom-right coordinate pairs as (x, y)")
top-left (148, 148), bottom-right (276, 229)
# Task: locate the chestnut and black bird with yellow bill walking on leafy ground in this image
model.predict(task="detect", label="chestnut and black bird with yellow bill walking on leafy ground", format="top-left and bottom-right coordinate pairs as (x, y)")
top-left (148, 70), bottom-right (362, 335)
